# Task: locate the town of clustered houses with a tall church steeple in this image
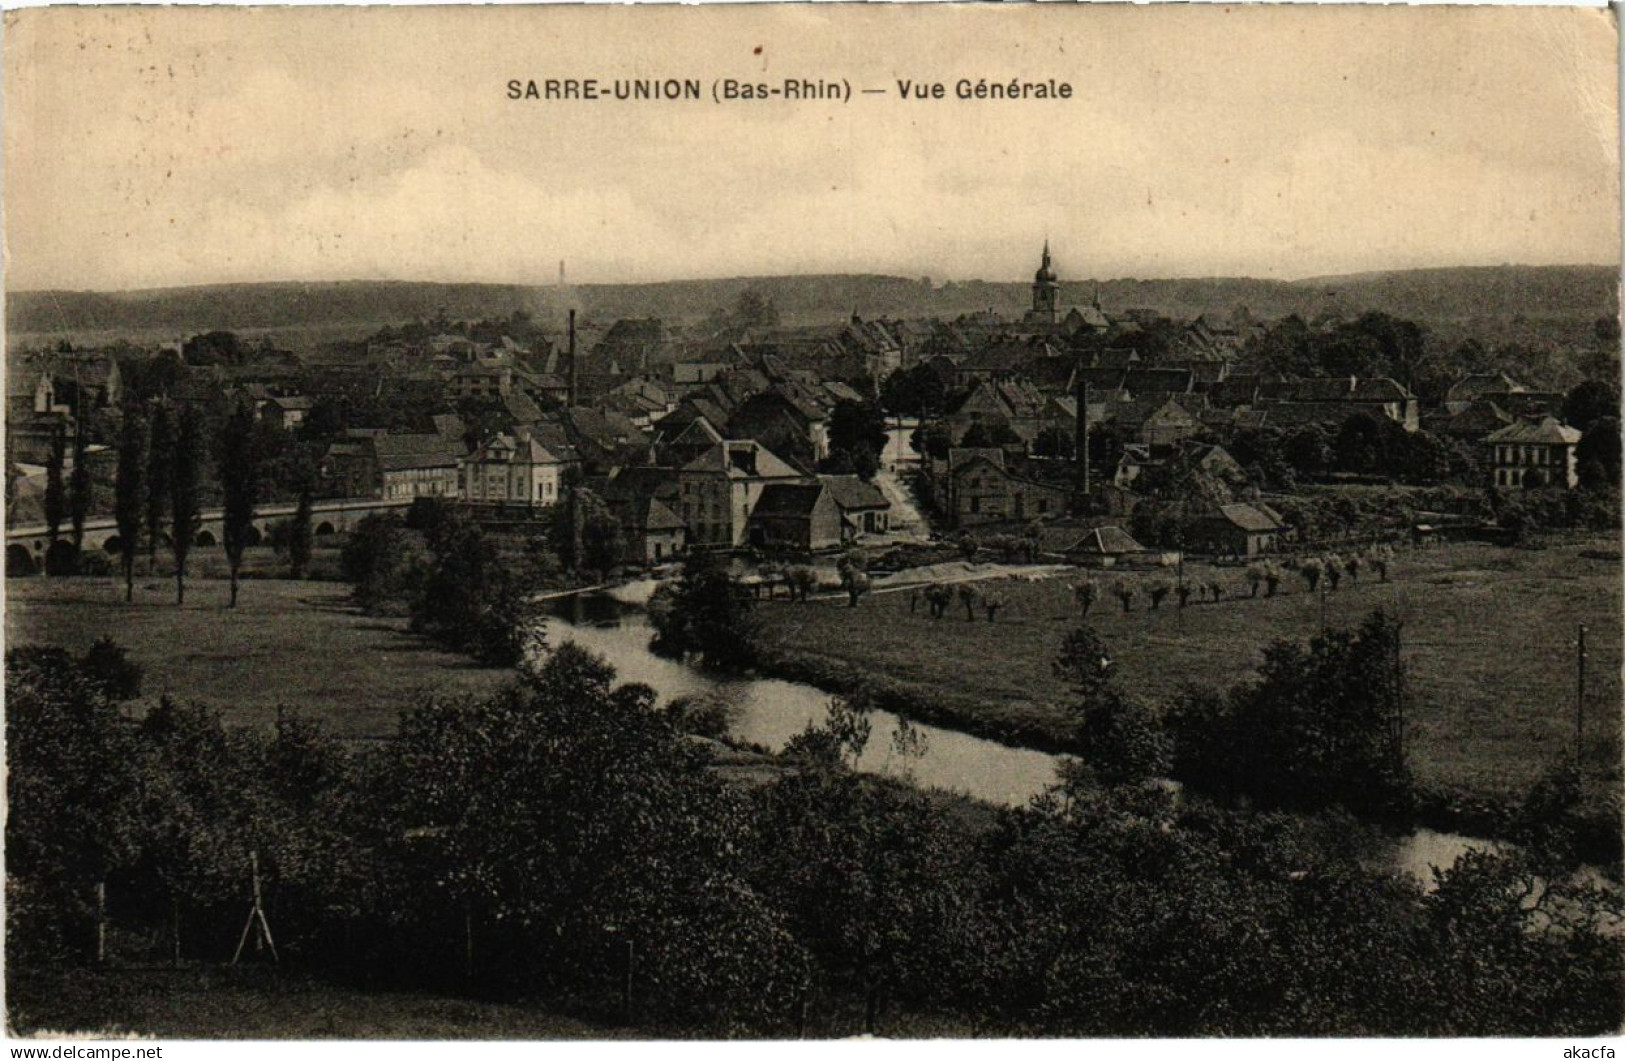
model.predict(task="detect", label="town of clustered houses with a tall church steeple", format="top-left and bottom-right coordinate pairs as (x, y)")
top-left (7, 244), bottom-right (1619, 575)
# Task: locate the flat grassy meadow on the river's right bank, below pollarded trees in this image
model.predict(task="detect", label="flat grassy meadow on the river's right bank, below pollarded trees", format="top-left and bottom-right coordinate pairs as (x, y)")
top-left (759, 539), bottom-right (1620, 798)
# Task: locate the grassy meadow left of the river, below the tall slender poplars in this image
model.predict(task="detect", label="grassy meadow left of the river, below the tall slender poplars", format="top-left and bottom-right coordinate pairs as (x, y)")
top-left (5, 578), bottom-right (510, 738)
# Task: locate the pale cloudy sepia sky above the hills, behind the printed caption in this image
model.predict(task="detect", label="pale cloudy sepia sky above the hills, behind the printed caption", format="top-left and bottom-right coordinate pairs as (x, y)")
top-left (3, 5), bottom-right (1620, 291)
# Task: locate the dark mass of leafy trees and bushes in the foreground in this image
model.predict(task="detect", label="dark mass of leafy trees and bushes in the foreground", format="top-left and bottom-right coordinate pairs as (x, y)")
top-left (7, 626), bottom-right (1622, 1035)
